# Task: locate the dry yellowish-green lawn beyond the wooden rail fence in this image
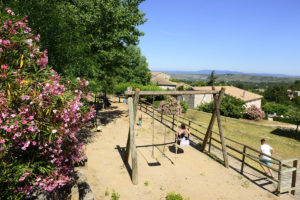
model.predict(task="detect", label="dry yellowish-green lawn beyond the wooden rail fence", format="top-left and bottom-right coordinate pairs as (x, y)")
top-left (185, 110), bottom-right (300, 167)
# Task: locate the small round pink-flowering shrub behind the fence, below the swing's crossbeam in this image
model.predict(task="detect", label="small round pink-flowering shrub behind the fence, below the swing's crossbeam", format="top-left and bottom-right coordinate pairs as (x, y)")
top-left (159, 97), bottom-right (182, 115)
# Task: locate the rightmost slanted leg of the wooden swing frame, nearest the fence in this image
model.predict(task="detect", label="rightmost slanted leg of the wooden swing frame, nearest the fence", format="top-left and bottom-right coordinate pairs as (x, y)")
top-left (215, 88), bottom-right (229, 168)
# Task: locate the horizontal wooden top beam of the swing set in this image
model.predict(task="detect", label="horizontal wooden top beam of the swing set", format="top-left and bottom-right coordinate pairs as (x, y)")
top-left (125, 90), bottom-right (220, 96)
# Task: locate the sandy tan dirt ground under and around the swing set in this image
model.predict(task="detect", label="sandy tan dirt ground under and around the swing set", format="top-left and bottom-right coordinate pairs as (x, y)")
top-left (83, 99), bottom-right (285, 200)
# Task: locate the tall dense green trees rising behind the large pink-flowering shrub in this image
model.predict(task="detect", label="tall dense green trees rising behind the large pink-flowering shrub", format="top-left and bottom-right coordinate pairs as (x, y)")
top-left (1, 0), bottom-right (151, 92)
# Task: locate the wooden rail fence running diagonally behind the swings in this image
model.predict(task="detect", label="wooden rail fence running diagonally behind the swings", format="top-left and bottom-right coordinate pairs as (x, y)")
top-left (138, 101), bottom-right (298, 195)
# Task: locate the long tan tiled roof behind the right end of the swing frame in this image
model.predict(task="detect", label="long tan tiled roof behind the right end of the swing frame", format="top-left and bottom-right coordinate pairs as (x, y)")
top-left (192, 86), bottom-right (263, 102)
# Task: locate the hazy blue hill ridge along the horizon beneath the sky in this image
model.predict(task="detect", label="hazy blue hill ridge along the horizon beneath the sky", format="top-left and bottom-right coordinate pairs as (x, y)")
top-left (163, 70), bottom-right (300, 78)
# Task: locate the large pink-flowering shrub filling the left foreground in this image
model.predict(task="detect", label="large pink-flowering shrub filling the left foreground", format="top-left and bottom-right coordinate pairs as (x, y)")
top-left (0, 7), bottom-right (94, 199)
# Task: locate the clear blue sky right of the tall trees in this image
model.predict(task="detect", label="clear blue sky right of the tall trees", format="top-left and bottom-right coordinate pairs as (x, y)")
top-left (139, 0), bottom-right (300, 75)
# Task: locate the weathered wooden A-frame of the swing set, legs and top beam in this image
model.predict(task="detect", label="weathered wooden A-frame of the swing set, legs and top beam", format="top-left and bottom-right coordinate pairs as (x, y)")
top-left (124, 87), bottom-right (228, 185)
